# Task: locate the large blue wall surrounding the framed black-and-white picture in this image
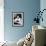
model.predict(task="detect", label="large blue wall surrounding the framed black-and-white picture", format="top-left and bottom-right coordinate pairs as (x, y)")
top-left (4, 0), bottom-right (40, 41)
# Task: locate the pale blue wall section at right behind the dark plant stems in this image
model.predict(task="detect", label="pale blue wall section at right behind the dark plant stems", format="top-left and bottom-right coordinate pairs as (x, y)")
top-left (40, 0), bottom-right (46, 27)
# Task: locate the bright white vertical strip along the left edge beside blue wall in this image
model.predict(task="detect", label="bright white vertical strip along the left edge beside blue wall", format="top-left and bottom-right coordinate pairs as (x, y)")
top-left (0, 0), bottom-right (4, 42)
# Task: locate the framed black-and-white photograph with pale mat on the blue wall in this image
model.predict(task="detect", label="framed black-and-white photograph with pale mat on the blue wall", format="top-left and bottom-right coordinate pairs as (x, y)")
top-left (12, 12), bottom-right (24, 27)
